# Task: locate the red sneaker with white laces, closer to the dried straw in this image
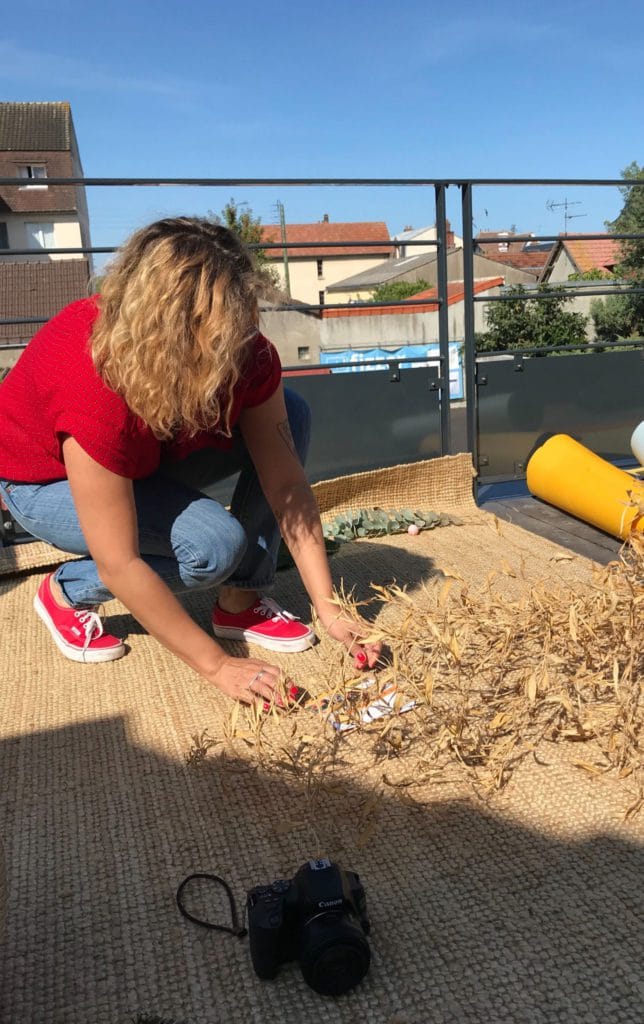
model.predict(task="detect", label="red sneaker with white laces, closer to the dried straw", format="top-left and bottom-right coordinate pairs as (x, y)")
top-left (212, 597), bottom-right (315, 651)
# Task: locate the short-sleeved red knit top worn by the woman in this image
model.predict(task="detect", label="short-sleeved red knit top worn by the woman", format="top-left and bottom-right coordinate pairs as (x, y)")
top-left (0, 296), bottom-right (282, 483)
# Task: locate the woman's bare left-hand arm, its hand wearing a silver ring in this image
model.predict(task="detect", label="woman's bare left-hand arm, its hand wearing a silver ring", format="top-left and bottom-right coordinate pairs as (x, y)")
top-left (62, 437), bottom-right (284, 700)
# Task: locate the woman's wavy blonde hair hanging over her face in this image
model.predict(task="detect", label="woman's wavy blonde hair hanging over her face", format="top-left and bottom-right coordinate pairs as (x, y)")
top-left (91, 217), bottom-right (260, 440)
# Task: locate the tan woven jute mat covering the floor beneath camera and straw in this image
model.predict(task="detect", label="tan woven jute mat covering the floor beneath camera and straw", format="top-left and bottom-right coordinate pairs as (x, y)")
top-left (0, 460), bottom-right (644, 1024)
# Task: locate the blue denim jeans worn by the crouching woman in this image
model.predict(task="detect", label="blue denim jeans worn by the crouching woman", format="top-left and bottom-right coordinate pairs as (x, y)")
top-left (0, 389), bottom-right (310, 607)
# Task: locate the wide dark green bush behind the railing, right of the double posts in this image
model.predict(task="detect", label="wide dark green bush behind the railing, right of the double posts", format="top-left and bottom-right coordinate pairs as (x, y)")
top-left (476, 285), bottom-right (588, 352)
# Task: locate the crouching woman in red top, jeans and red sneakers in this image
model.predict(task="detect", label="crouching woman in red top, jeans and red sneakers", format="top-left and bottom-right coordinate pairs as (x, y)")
top-left (0, 217), bottom-right (380, 701)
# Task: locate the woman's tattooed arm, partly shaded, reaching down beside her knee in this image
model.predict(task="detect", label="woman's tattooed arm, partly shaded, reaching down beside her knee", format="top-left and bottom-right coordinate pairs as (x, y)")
top-left (240, 386), bottom-right (380, 667)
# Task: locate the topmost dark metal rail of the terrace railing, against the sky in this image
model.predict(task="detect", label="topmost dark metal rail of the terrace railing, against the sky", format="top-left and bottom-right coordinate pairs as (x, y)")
top-left (0, 177), bottom-right (644, 188)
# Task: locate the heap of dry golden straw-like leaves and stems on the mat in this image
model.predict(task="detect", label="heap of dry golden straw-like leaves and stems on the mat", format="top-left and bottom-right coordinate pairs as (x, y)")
top-left (217, 537), bottom-right (644, 822)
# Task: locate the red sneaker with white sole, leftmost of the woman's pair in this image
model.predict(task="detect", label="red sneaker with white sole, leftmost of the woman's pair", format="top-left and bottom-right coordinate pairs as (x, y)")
top-left (34, 573), bottom-right (125, 662)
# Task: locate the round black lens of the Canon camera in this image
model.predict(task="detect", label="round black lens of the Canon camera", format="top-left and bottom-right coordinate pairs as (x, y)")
top-left (300, 914), bottom-right (371, 995)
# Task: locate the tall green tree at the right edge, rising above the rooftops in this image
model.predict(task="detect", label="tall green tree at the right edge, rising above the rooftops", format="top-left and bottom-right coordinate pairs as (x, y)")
top-left (591, 161), bottom-right (644, 341)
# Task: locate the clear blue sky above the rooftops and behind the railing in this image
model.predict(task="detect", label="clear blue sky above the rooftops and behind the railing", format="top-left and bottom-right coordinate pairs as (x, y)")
top-left (0, 0), bottom-right (644, 245)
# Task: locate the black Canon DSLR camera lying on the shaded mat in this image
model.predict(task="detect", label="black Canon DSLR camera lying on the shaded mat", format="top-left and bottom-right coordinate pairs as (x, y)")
top-left (247, 860), bottom-right (371, 995)
